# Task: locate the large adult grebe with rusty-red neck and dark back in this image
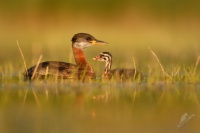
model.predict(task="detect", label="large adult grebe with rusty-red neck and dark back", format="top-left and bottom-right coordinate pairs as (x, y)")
top-left (24, 33), bottom-right (107, 80)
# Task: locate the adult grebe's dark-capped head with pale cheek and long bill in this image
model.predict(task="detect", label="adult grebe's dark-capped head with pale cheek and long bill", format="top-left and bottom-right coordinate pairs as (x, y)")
top-left (72, 33), bottom-right (107, 49)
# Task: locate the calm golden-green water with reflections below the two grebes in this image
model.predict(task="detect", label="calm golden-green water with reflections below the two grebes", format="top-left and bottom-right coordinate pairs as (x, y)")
top-left (0, 79), bottom-right (200, 133)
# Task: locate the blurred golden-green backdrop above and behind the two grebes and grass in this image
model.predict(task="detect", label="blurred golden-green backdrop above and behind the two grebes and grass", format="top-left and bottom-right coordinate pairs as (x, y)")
top-left (0, 0), bottom-right (200, 74)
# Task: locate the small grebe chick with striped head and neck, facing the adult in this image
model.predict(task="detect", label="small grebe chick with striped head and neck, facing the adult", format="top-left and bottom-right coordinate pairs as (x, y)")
top-left (93, 52), bottom-right (140, 80)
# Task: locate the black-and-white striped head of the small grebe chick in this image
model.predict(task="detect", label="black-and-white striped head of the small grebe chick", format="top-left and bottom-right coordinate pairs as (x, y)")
top-left (93, 52), bottom-right (112, 62)
